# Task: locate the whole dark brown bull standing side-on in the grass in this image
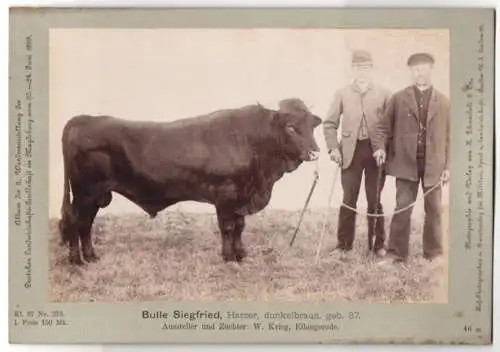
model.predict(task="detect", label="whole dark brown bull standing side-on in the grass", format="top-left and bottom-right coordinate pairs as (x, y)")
top-left (59, 99), bottom-right (321, 264)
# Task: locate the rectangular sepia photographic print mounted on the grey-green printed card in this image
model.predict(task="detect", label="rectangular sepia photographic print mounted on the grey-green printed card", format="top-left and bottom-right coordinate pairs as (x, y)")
top-left (47, 28), bottom-right (453, 304)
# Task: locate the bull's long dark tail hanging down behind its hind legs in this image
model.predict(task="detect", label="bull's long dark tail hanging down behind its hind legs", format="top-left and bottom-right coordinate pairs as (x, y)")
top-left (59, 123), bottom-right (73, 244)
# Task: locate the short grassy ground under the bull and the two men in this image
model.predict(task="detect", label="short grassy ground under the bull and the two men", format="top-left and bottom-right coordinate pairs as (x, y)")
top-left (49, 210), bottom-right (448, 302)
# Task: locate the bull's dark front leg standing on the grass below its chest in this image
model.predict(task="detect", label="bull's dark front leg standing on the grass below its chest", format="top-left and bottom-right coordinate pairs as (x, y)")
top-left (217, 207), bottom-right (246, 262)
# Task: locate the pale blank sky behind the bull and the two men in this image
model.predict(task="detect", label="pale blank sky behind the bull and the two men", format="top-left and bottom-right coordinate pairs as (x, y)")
top-left (49, 29), bottom-right (450, 217)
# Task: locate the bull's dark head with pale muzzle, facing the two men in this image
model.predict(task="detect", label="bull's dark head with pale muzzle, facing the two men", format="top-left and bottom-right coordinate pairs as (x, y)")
top-left (273, 98), bottom-right (322, 161)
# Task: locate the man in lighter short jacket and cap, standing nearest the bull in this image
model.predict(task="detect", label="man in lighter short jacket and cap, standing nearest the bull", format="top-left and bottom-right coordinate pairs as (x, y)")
top-left (323, 50), bottom-right (390, 256)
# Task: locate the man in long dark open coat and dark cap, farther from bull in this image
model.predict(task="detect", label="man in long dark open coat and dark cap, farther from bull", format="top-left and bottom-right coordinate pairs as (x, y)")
top-left (374, 53), bottom-right (450, 262)
